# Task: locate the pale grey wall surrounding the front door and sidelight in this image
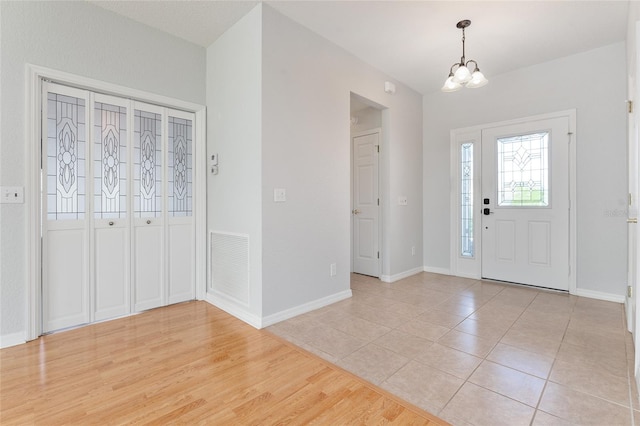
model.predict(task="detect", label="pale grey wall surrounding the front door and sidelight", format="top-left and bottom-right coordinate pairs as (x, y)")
top-left (423, 43), bottom-right (627, 295)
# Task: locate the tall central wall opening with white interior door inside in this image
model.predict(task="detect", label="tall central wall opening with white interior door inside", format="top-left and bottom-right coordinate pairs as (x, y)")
top-left (350, 93), bottom-right (383, 278)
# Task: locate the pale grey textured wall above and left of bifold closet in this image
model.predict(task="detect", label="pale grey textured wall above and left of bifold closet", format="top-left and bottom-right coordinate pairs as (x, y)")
top-left (0, 1), bottom-right (205, 342)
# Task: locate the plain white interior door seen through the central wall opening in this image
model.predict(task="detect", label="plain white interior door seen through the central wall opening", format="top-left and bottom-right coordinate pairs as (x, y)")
top-left (351, 130), bottom-right (380, 277)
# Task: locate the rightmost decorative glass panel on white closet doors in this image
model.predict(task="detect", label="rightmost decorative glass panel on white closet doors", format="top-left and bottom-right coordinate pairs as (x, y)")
top-left (168, 117), bottom-right (193, 217)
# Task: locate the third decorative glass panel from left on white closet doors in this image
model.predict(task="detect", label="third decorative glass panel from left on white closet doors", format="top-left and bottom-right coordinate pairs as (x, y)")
top-left (133, 110), bottom-right (162, 217)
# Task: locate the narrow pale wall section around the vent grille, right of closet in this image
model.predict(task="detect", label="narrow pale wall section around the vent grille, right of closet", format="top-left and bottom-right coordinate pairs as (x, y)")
top-left (207, 6), bottom-right (262, 325)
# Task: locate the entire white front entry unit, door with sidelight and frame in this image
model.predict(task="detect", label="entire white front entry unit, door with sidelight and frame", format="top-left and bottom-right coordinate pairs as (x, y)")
top-left (451, 110), bottom-right (576, 293)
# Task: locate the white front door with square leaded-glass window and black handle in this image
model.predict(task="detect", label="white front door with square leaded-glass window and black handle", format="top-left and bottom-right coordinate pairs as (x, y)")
top-left (480, 117), bottom-right (570, 290)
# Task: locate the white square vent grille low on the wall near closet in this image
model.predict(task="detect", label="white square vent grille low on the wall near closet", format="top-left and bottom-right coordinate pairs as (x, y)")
top-left (209, 232), bottom-right (249, 304)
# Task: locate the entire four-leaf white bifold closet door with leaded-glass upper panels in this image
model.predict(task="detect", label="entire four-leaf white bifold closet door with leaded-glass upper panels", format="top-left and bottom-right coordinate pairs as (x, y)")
top-left (42, 83), bottom-right (195, 332)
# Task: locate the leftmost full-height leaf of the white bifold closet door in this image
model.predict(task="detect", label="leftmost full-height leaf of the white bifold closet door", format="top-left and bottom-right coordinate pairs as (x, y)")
top-left (42, 83), bottom-right (91, 332)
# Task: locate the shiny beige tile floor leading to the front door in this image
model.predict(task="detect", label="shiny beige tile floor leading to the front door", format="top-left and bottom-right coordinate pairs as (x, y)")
top-left (268, 273), bottom-right (640, 426)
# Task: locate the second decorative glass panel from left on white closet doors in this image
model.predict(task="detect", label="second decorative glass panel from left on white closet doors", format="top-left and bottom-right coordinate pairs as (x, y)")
top-left (93, 102), bottom-right (127, 219)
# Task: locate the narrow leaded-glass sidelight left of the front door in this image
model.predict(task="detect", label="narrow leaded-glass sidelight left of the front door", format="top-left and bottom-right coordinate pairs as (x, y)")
top-left (460, 142), bottom-right (475, 257)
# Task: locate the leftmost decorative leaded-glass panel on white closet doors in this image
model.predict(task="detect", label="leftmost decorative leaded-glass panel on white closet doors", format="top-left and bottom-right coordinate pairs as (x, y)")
top-left (47, 93), bottom-right (86, 220)
